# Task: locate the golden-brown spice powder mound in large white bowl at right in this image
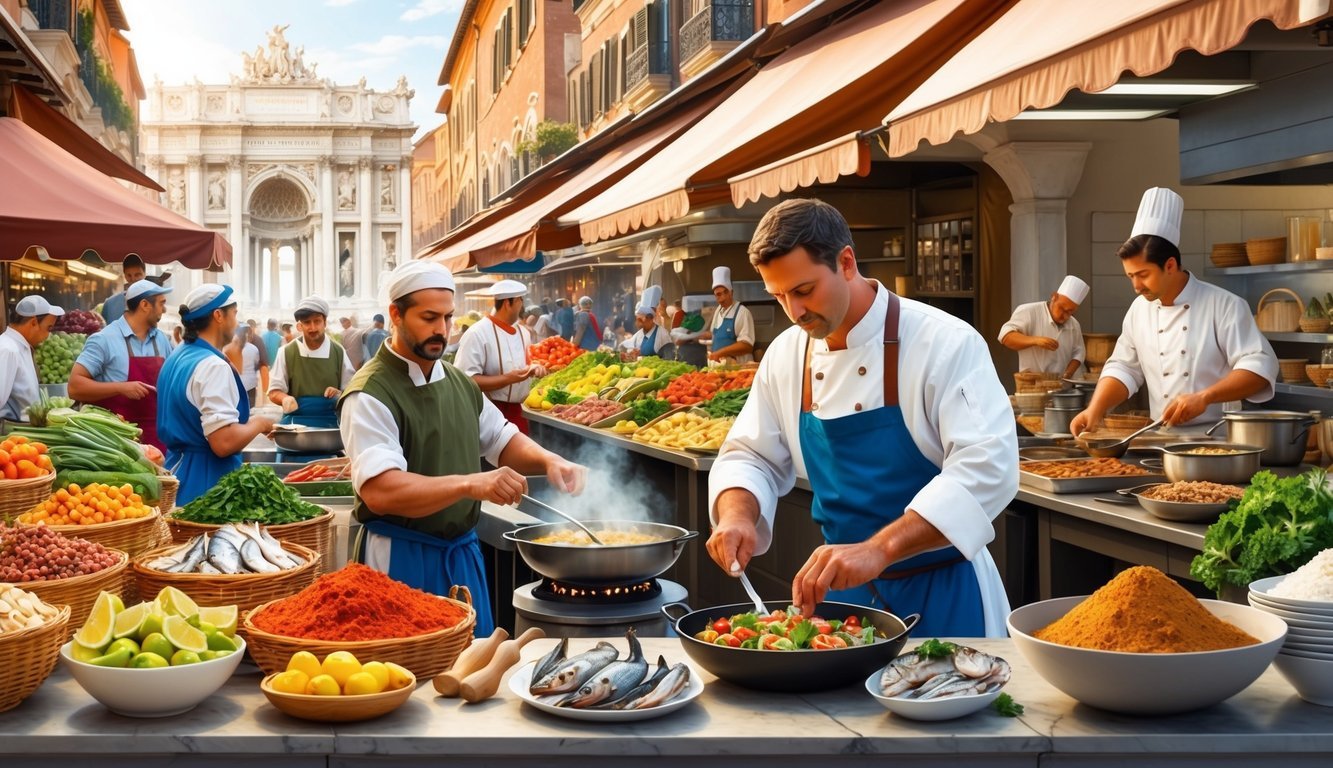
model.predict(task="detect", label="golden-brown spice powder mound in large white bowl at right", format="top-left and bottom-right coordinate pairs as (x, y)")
top-left (1036, 565), bottom-right (1258, 653)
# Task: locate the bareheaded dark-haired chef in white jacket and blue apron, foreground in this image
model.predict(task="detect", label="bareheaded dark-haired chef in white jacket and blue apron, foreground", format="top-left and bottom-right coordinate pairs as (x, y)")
top-left (708, 200), bottom-right (1018, 637)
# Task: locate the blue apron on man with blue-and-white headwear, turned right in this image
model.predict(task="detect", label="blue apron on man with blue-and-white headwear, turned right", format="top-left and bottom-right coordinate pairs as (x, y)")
top-left (157, 339), bottom-right (249, 505)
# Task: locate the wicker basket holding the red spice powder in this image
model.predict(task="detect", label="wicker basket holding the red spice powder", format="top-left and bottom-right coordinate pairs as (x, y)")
top-left (241, 587), bottom-right (477, 680)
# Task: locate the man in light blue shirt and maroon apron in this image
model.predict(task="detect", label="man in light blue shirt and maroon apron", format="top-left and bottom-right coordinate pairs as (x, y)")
top-left (69, 280), bottom-right (172, 451)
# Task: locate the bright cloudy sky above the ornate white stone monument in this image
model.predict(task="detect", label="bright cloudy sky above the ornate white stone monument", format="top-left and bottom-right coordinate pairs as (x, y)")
top-left (120, 0), bottom-right (463, 139)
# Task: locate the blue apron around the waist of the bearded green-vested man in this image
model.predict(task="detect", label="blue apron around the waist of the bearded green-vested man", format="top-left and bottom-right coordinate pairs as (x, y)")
top-left (361, 520), bottom-right (495, 637)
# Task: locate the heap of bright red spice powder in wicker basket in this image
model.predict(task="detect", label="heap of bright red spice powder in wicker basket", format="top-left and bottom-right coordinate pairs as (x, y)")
top-left (251, 563), bottom-right (468, 640)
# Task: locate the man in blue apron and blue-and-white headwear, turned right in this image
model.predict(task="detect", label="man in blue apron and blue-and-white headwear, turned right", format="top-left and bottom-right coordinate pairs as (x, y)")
top-left (159, 283), bottom-right (273, 504)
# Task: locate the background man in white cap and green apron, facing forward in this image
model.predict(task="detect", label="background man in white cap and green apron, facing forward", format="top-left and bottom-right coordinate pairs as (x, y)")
top-left (268, 296), bottom-right (355, 453)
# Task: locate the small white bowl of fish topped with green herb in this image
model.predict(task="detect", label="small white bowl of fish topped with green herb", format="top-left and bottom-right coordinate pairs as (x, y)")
top-left (865, 640), bottom-right (1010, 720)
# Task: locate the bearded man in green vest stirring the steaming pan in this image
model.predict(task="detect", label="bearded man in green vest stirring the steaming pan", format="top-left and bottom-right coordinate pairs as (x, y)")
top-left (339, 260), bottom-right (585, 636)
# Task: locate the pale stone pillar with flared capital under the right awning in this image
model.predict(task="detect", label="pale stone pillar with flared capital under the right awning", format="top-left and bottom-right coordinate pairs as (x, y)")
top-left (982, 141), bottom-right (1092, 305)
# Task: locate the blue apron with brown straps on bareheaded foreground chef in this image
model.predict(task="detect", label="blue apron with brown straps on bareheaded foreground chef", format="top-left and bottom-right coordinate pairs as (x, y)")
top-left (794, 293), bottom-right (985, 637)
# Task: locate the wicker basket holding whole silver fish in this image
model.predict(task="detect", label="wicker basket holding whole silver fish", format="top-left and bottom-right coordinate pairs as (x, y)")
top-left (131, 541), bottom-right (320, 611)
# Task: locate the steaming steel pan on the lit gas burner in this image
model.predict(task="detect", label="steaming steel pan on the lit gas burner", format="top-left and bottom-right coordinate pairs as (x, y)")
top-left (504, 520), bottom-right (698, 584)
